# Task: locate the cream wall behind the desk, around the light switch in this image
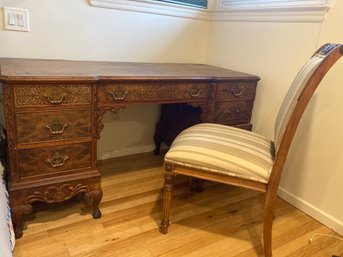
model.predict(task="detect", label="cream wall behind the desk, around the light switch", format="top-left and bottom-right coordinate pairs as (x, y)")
top-left (0, 0), bottom-right (208, 159)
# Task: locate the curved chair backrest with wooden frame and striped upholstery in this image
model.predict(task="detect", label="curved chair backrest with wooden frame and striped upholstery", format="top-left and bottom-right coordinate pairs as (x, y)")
top-left (269, 44), bottom-right (343, 184)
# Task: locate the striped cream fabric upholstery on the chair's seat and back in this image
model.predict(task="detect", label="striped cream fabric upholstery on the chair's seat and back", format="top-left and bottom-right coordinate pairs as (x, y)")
top-left (165, 54), bottom-right (325, 183)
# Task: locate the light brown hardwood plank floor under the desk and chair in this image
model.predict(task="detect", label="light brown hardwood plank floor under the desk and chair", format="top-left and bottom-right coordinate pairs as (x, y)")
top-left (14, 154), bottom-right (343, 257)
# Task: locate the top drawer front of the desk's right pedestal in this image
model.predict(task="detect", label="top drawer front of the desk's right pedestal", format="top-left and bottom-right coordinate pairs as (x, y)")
top-left (217, 82), bottom-right (256, 99)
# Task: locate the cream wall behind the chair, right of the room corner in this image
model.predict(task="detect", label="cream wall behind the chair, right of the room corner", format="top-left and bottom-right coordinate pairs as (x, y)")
top-left (207, 1), bottom-right (343, 234)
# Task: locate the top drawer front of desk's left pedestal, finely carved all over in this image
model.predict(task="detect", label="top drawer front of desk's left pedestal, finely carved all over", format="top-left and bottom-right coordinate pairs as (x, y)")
top-left (14, 84), bottom-right (91, 107)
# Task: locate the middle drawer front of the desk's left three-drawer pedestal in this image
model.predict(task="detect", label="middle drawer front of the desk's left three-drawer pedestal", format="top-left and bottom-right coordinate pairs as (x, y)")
top-left (16, 110), bottom-right (91, 144)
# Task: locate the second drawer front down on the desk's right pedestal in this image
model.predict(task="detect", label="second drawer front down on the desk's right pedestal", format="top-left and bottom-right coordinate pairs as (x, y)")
top-left (213, 100), bottom-right (253, 125)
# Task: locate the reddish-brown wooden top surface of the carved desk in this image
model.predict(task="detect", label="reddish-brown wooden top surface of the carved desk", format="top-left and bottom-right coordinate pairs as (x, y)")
top-left (0, 58), bottom-right (259, 82)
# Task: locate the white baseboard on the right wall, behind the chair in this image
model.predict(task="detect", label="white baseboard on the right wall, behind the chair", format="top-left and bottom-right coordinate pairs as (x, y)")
top-left (278, 187), bottom-right (343, 236)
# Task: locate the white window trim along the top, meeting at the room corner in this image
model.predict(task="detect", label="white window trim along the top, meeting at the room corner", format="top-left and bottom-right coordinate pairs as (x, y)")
top-left (90, 0), bottom-right (330, 22)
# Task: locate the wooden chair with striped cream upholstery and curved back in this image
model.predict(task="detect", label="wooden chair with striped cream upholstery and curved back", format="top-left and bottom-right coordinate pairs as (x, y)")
top-left (160, 44), bottom-right (343, 257)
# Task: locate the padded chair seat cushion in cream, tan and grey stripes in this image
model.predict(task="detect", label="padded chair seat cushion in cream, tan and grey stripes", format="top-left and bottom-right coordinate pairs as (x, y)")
top-left (165, 123), bottom-right (274, 183)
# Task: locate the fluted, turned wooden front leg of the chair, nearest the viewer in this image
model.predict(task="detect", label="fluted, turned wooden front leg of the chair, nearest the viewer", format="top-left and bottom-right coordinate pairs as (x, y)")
top-left (160, 164), bottom-right (174, 234)
